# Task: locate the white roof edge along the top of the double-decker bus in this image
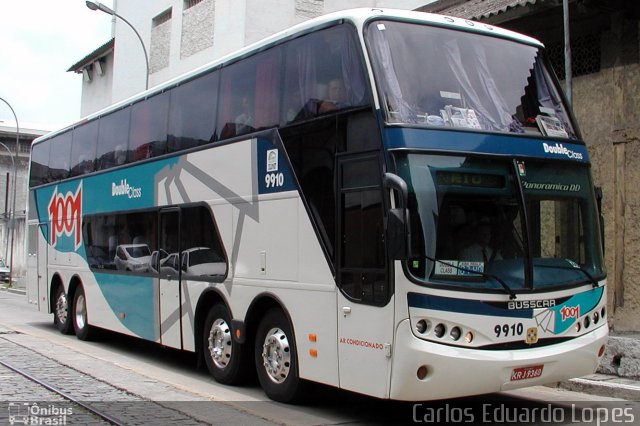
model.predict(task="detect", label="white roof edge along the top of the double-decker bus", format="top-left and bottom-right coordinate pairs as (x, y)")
top-left (32, 8), bottom-right (543, 145)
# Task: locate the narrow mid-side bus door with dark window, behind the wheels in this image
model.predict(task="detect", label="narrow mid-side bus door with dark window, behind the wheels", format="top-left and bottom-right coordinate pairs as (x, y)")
top-left (158, 209), bottom-right (182, 349)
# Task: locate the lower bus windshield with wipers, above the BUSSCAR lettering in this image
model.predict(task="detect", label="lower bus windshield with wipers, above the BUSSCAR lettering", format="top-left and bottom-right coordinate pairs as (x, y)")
top-left (396, 153), bottom-right (604, 290)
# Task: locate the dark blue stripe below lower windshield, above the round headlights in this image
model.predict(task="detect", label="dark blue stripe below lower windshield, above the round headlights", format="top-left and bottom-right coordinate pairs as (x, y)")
top-left (407, 293), bottom-right (533, 318)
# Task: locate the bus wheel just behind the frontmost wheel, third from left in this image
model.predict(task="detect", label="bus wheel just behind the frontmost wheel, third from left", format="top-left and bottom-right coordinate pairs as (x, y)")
top-left (202, 303), bottom-right (252, 385)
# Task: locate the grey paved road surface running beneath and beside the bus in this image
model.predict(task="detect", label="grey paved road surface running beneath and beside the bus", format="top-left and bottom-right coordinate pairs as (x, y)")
top-left (0, 291), bottom-right (640, 425)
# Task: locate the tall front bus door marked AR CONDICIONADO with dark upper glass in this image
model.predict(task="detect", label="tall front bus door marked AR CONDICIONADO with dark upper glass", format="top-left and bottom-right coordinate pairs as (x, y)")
top-left (337, 153), bottom-right (394, 398)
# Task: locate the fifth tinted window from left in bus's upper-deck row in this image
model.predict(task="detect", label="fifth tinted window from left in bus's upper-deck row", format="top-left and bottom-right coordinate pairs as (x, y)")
top-left (128, 92), bottom-right (169, 162)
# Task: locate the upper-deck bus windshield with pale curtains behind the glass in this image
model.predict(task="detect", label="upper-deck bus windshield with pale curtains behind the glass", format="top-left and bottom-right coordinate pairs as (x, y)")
top-left (366, 21), bottom-right (576, 139)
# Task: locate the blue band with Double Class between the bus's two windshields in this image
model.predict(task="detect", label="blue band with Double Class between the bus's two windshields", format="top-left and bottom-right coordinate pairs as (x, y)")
top-left (384, 127), bottom-right (589, 163)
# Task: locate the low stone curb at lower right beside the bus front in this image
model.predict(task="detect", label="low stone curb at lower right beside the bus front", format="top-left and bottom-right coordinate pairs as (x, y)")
top-left (556, 374), bottom-right (640, 401)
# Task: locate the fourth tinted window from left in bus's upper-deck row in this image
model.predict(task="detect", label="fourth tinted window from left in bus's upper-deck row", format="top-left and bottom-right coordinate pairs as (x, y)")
top-left (96, 108), bottom-right (131, 170)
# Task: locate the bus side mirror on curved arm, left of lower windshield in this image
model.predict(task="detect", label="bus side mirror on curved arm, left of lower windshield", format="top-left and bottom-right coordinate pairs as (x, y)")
top-left (384, 173), bottom-right (411, 260)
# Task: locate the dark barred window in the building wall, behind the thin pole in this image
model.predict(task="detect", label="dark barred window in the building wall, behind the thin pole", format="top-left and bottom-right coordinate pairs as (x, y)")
top-left (547, 33), bottom-right (601, 80)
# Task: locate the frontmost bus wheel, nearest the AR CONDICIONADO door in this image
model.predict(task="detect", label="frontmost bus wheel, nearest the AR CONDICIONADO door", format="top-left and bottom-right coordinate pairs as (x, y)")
top-left (255, 309), bottom-right (307, 403)
